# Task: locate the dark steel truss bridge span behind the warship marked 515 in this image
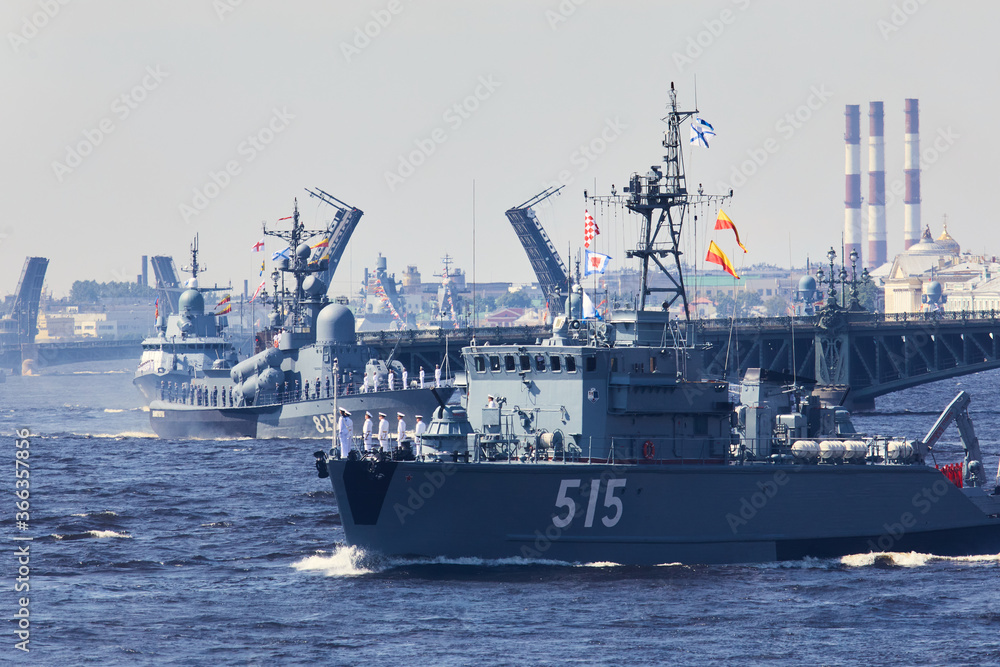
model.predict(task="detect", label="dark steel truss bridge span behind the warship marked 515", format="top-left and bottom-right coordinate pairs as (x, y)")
top-left (358, 311), bottom-right (1000, 410)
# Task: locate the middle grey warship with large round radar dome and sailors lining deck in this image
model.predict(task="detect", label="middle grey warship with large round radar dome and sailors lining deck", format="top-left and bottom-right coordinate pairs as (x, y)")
top-left (143, 188), bottom-right (453, 439)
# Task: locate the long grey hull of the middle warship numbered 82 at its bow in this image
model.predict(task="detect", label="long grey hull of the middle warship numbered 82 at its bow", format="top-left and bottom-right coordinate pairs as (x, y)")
top-left (149, 389), bottom-right (451, 440)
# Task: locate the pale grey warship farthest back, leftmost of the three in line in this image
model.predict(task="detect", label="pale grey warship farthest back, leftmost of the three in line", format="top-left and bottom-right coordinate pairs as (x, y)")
top-left (132, 236), bottom-right (239, 404)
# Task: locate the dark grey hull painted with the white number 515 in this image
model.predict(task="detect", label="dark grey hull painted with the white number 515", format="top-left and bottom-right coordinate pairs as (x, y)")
top-left (328, 461), bottom-right (1000, 565)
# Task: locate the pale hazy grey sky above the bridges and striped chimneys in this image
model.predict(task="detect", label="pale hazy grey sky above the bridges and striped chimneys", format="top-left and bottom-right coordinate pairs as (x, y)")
top-left (0, 0), bottom-right (1000, 296)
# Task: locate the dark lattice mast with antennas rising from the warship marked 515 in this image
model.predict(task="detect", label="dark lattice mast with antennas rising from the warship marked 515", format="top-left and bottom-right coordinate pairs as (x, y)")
top-left (592, 82), bottom-right (732, 320)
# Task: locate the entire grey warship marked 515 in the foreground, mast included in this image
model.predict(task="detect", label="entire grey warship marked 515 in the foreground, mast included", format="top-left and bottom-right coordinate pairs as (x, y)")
top-left (316, 86), bottom-right (1000, 565)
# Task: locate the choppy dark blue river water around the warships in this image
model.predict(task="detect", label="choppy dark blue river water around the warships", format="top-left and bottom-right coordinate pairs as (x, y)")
top-left (0, 363), bottom-right (1000, 665)
